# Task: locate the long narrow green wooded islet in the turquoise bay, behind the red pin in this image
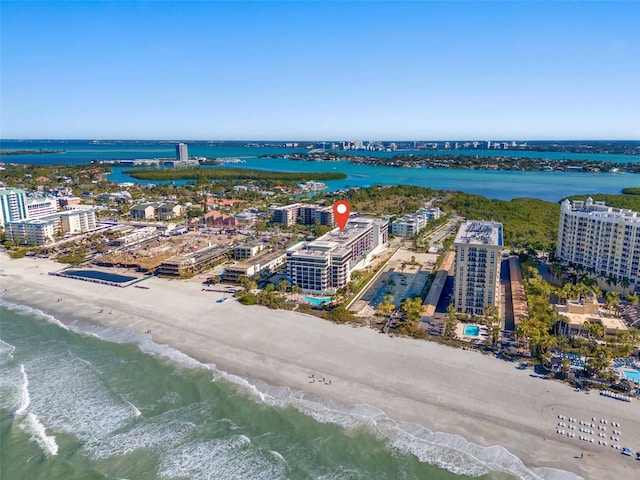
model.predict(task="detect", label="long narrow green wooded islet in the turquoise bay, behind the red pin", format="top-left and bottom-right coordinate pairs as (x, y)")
top-left (123, 167), bottom-right (347, 182)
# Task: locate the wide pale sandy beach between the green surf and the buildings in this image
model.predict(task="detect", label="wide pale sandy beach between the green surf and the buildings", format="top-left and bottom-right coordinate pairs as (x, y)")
top-left (0, 255), bottom-right (640, 479)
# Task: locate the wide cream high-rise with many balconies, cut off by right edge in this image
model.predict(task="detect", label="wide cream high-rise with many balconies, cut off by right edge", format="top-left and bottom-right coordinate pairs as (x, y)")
top-left (556, 197), bottom-right (640, 288)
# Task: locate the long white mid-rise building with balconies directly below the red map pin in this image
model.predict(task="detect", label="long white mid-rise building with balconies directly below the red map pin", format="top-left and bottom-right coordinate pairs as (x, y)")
top-left (287, 218), bottom-right (389, 293)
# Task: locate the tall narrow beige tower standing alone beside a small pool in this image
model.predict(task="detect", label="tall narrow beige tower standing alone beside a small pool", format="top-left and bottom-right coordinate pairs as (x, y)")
top-left (453, 220), bottom-right (503, 315)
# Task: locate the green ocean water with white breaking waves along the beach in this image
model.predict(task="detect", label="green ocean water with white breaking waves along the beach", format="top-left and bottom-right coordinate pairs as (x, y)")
top-left (0, 303), bottom-right (574, 480)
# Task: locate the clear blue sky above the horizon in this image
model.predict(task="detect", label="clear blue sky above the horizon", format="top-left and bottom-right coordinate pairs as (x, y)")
top-left (0, 0), bottom-right (640, 140)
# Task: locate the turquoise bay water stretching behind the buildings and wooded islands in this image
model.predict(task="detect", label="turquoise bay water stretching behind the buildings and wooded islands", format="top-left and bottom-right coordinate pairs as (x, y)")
top-left (0, 141), bottom-right (640, 201)
